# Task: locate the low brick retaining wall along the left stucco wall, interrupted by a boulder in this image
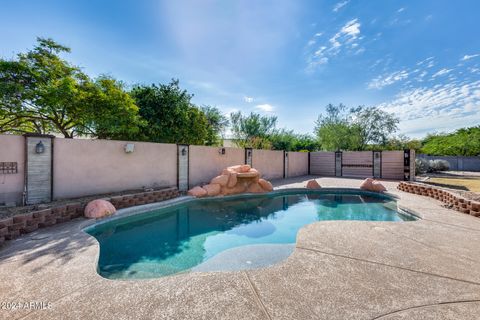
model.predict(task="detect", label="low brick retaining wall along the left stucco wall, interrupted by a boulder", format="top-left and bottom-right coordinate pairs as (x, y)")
top-left (0, 188), bottom-right (179, 244)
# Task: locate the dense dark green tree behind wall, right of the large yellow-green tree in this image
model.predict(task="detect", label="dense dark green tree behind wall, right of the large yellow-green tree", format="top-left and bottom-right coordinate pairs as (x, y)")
top-left (130, 79), bottom-right (208, 145)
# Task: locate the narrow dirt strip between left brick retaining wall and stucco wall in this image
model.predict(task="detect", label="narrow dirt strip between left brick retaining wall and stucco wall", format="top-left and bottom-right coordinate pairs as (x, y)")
top-left (0, 188), bottom-right (176, 219)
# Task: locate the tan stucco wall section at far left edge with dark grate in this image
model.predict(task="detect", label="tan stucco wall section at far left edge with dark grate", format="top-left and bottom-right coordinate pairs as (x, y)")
top-left (0, 135), bottom-right (25, 204)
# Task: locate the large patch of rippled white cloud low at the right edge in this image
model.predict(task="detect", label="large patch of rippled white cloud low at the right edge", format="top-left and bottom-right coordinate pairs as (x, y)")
top-left (374, 57), bottom-right (480, 137)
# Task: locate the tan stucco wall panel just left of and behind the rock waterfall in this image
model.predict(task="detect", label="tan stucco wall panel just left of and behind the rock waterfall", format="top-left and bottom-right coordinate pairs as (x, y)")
top-left (189, 146), bottom-right (245, 187)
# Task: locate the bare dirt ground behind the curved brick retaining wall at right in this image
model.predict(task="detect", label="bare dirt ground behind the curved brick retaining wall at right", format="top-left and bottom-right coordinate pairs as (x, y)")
top-left (417, 171), bottom-right (480, 201)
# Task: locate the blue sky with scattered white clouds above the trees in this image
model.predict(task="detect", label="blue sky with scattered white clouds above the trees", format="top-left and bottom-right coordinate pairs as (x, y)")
top-left (0, 0), bottom-right (480, 137)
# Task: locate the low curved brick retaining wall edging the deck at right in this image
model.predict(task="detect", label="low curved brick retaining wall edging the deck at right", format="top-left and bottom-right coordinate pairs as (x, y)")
top-left (398, 182), bottom-right (480, 217)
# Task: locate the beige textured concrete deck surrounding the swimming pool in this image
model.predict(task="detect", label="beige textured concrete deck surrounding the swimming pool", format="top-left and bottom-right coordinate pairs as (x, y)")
top-left (0, 177), bottom-right (480, 319)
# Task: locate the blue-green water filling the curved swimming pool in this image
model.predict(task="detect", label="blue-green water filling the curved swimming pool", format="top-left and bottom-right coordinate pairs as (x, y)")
top-left (86, 192), bottom-right (413, 279)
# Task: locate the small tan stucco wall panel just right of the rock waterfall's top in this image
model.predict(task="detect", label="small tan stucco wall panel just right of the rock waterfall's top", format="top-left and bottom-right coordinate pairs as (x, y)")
top-left (252, 149), bottom-right (283, 179)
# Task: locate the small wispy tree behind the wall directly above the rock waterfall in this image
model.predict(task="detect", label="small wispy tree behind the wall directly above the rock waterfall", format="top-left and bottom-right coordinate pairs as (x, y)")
top-left (230, 111), bottom-right (277, 149)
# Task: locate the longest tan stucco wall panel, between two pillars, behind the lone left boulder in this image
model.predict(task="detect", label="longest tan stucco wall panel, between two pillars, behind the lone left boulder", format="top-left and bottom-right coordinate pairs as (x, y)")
top-left (53, 139), bottom-right (177, 199)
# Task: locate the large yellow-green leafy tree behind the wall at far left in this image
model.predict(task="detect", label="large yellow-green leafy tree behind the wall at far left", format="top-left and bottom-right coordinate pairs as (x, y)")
top-left (0, 38), bottom-right (142, 138)
